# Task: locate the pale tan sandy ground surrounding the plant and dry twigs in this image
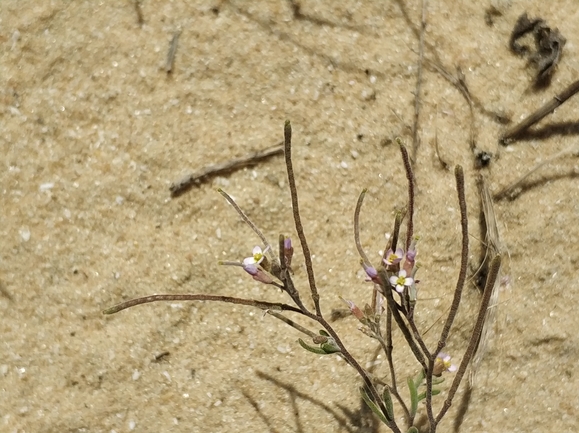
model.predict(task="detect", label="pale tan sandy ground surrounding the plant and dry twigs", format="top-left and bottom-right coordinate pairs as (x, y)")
top-left (0, 0), bottom-right (579, 433)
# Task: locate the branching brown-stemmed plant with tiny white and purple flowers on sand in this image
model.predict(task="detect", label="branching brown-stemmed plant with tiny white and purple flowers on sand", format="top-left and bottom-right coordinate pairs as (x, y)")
top-left (104, 121), bottom-right (501, 433)
